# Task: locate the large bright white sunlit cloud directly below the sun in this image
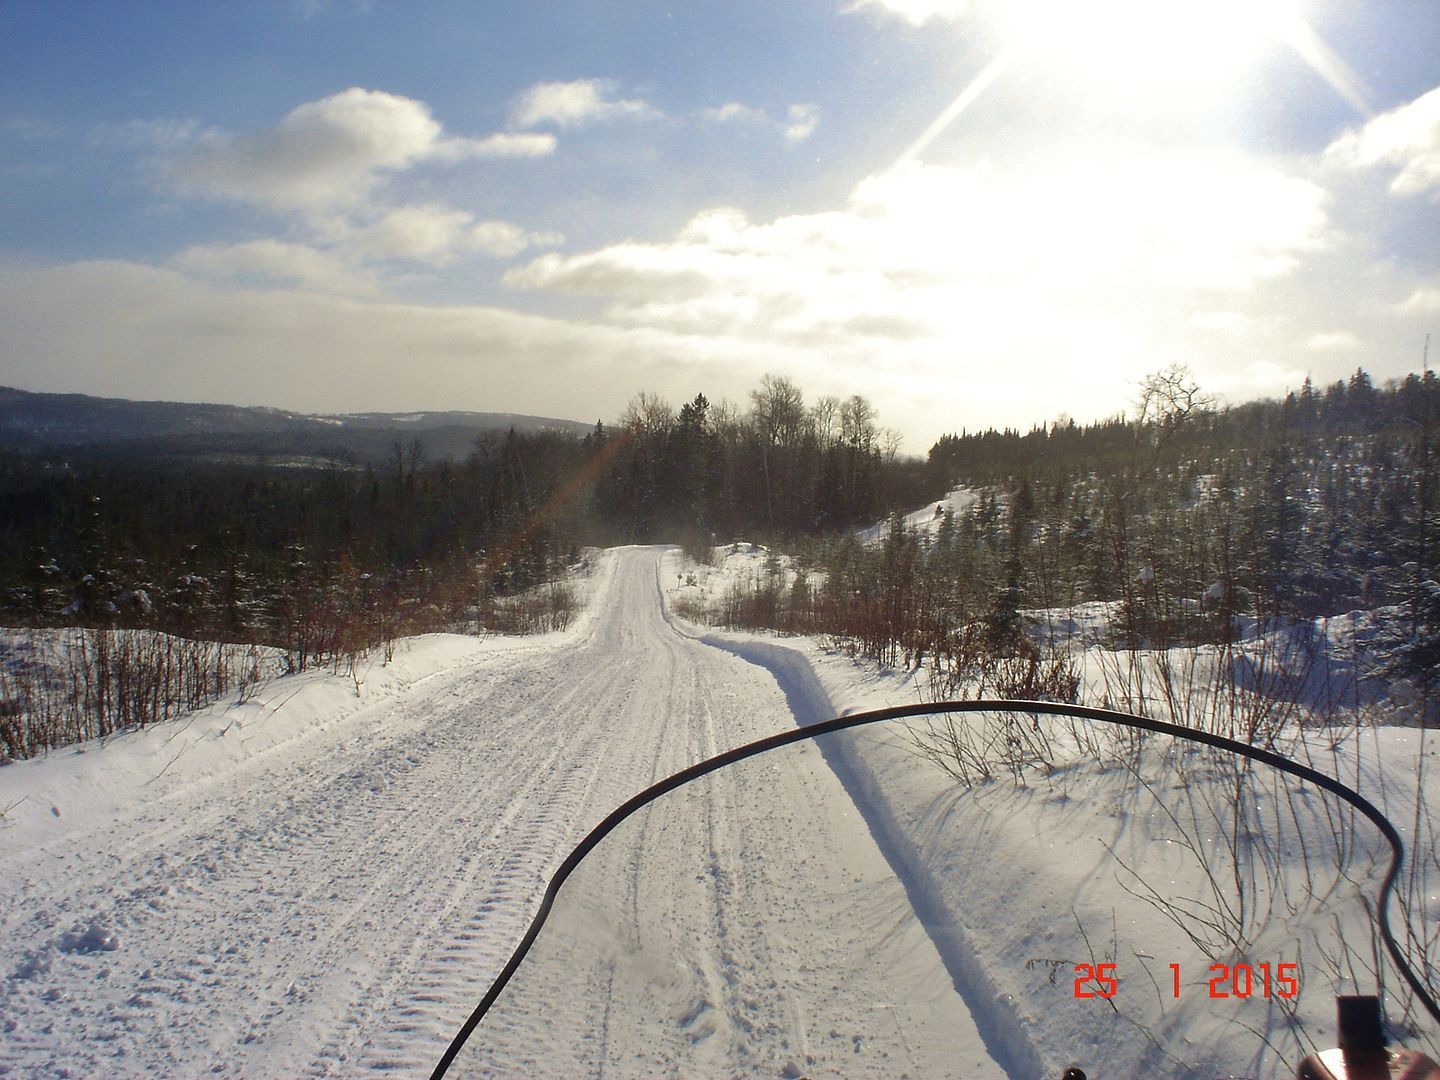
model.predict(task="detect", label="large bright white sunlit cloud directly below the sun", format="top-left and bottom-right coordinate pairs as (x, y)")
top-left (492, 148), bottom-right (1375, 440)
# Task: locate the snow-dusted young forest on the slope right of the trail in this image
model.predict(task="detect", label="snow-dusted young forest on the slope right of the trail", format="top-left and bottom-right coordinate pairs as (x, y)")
top-left (705, 367), bottom-right (1440, 714)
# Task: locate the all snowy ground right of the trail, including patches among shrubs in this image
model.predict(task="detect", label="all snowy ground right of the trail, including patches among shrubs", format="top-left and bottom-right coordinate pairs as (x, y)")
top-left (662, 549), bottom-right (1440, 1077)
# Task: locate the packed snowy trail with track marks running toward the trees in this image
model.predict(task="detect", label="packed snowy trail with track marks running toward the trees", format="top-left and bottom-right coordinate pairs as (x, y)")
top-left (0, 549), bottom-right (1002, 1076)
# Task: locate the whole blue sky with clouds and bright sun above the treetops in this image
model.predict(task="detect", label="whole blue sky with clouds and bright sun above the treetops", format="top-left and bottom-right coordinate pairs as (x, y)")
top-left (0, 0), bottom-right (1440, 454)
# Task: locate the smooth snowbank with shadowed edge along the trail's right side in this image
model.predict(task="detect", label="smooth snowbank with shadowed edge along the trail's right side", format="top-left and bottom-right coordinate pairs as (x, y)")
top-left (661, 553), bottom-right (1440, 1077)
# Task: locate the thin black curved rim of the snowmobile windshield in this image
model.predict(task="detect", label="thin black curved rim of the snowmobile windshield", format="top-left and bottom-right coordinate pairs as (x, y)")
top-left (431, 698), bottom-right (1440, 1080)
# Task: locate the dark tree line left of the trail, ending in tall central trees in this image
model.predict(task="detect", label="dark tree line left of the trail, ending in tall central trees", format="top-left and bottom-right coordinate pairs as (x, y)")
top-left (0, 376), bottom-right (937, 667)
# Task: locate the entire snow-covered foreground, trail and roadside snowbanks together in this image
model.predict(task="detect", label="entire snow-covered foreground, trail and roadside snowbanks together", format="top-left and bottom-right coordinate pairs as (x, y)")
top-left (0, 549), bottom-right (1440, 1077)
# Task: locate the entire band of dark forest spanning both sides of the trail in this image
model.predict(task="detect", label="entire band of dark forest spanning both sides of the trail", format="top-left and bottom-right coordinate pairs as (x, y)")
top-left (0, 369), bottom-right (1440, 756)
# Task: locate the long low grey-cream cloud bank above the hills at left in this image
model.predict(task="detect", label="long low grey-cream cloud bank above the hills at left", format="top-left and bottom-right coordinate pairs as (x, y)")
top-left (0, 262), bottom-right (798, 422)
